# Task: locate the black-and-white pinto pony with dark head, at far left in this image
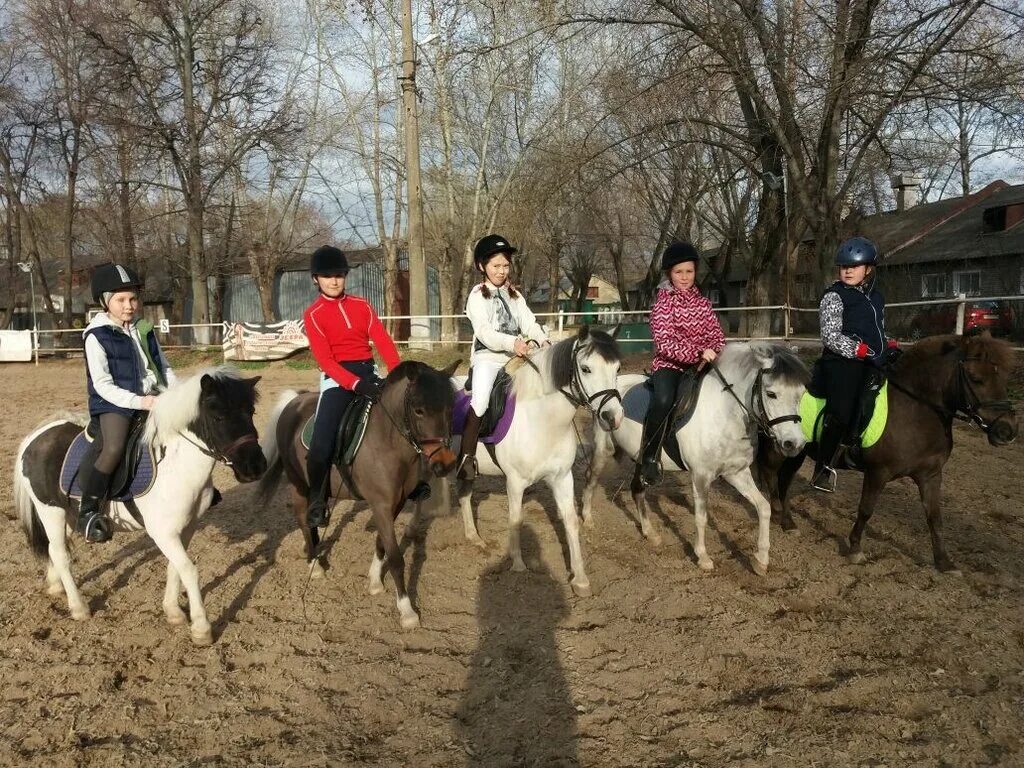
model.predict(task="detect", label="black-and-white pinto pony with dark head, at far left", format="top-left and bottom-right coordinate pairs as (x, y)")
top-left (14, 369), bottom-right (266, 645)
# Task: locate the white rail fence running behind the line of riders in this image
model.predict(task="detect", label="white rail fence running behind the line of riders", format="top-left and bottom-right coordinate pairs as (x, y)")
top-left (9, 295), bottom-right (1024, 365)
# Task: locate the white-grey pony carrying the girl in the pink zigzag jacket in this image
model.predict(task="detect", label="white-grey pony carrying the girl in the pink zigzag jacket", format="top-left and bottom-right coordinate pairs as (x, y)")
top-left (583, 341), bottom-right (810, 574)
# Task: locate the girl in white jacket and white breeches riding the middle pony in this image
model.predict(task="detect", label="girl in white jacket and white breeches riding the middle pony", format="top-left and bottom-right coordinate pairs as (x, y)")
top-left (459, 234), bottom-right (548, 482)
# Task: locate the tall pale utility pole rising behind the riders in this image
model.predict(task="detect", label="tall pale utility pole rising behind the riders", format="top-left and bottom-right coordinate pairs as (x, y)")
top-left (399, 0), bottom-right (430, 349)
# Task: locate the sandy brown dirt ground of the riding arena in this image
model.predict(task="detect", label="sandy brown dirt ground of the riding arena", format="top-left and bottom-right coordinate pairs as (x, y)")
top-left (0, 360), bottom-right (1024, 767)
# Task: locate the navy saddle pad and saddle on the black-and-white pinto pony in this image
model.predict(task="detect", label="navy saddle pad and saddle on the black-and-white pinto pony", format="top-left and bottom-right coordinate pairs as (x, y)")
top-left (60, 411), bottom-right (157, 502)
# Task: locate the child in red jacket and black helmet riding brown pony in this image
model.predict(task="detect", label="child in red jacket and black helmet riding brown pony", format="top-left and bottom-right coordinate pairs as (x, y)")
top-left (302, 246), bottom-right (399, 527)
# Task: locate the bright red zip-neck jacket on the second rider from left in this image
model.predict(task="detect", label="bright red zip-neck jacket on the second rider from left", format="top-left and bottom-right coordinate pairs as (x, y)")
top-left (302, 294), bottom-right (400, 389)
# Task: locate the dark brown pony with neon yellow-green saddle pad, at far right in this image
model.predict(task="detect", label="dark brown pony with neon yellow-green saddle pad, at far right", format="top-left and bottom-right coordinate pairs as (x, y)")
top-left (758, 334), bottom-right (1017, 571)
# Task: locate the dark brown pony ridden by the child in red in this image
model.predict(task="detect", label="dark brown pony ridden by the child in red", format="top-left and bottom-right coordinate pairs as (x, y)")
top-left (259, 360), bottom-right (459, 629)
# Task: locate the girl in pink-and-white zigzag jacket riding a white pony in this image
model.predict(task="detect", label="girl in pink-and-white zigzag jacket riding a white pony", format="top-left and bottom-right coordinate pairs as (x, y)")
top-left (637, 241), bottom-right (725, 485)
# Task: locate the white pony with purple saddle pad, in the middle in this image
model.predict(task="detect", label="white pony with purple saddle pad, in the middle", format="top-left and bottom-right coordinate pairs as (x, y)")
top-left (452, 326), bottom-right (623, 597)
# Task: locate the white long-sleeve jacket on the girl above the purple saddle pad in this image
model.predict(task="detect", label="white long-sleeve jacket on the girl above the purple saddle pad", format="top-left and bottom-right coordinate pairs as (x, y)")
top-left (466, 281), bottom-right (548, 362)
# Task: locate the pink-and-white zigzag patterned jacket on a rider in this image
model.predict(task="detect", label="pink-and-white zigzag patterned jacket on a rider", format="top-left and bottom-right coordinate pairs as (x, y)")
top-left (650, 283), bottom-right (725, 371)
